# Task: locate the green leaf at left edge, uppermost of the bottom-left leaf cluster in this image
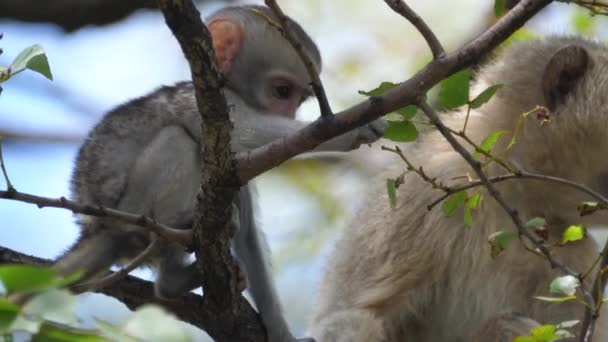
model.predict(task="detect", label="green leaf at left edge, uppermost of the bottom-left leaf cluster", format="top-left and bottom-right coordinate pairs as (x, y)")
top-left (0, 265), bottom-right (59, 293)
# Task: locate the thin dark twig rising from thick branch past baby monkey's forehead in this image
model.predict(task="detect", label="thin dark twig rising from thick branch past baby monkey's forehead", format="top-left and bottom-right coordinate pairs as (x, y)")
top-left (264, 0), bottom-right (333, 117)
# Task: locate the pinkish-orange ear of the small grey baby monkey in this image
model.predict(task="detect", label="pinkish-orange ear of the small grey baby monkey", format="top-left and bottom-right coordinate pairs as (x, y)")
top-left (207, 19), bottom-right (244, 77)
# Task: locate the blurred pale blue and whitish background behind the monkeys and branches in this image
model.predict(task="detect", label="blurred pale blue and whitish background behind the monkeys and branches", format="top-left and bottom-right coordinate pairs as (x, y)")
top-left (0, 0), bottom-right (608, 341)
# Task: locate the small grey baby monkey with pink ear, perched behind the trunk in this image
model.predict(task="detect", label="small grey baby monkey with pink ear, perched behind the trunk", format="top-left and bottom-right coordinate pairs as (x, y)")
top-left (54, 6), bottom-right (384, 342)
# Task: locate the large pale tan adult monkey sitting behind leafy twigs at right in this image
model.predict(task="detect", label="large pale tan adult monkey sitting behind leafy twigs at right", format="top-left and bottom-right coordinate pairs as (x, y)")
top-left (311, 37), bottom-right (608, 342)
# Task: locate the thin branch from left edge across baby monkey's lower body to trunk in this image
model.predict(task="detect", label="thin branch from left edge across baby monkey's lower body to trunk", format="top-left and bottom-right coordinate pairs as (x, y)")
top-left (0, 190), bottom-right (192, 246)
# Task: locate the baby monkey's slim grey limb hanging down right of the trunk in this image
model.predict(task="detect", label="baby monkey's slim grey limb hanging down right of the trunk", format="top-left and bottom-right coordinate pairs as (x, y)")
top-left (234, 185), bottom-right (293, 342)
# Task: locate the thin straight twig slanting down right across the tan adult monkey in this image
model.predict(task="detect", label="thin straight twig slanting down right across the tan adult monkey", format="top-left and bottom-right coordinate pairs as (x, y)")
top-left (417, 100), bottom-right (595, 307)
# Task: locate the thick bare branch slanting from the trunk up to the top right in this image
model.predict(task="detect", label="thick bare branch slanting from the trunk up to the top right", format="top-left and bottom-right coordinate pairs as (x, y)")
top-left (237, 0), bottom-right (551, 183)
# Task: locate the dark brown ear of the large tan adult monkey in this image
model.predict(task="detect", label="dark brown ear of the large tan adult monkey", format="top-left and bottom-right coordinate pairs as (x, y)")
top-left (542, 45), bottom-right (591, 110)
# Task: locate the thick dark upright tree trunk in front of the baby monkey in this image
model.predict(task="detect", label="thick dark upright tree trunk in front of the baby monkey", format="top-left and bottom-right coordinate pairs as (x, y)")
top-left (158, 0), bottom-right (266, 341)
